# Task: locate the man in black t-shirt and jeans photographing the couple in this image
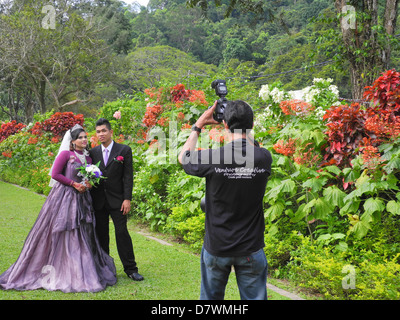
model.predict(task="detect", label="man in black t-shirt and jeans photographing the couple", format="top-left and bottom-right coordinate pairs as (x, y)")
top-left (179, 100), bottom-right (272, 300)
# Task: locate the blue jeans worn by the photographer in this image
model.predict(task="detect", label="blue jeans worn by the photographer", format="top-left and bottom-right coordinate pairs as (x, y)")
top-left (200, 247), bottom-right (268, 300)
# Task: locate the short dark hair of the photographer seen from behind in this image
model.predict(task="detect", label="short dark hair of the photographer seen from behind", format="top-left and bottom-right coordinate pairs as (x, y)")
top-left (224, 100), bottom-right (254, 133)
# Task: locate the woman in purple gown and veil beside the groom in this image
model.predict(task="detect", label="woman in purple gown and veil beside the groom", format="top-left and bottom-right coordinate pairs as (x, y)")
top-left (0, 125), bottom-right (117, 292)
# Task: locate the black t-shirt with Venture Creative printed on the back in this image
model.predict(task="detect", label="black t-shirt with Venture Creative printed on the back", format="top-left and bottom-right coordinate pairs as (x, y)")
top-left (182, 139), bottom-right (272, 257)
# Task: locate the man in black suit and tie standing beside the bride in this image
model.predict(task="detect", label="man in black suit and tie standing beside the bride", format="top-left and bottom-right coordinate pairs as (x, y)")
top-left (90, 118), bottom-right (143, 281)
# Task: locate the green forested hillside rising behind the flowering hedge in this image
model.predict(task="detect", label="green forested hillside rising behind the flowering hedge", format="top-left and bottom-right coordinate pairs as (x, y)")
top-left (0, 0), bottom-right (400, 122)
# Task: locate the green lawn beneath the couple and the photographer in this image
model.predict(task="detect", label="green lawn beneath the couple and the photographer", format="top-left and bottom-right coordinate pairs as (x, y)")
top-left (0, 181), bottom-right (287, 300)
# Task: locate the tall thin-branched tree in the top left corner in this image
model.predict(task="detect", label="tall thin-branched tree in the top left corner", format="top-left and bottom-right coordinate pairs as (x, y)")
top-left (0, 0), bottom-right (111, 120)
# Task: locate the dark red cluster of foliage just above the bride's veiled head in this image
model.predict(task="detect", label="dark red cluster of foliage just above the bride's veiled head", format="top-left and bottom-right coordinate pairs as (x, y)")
top-left (31, 112), bottom-right (85, 138)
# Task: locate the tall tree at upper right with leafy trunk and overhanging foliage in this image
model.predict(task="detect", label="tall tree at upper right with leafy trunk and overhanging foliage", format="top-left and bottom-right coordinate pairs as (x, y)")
top-left (186, 0), bottom-right (400, 99)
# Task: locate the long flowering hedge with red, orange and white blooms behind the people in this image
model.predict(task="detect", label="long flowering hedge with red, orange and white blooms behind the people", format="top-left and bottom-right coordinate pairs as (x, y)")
top-left (0, 71), bottom-right (400, 299)
